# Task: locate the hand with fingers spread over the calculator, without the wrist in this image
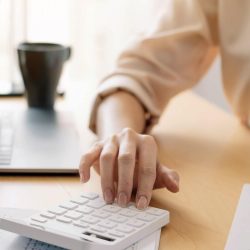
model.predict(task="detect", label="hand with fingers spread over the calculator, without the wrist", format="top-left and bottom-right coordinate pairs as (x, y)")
top-left (79, 128), bottom-right (179, 209)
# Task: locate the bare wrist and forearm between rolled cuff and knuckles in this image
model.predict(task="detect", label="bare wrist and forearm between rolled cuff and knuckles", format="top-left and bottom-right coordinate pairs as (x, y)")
top-left (97, 91), bottom-right (145, 139)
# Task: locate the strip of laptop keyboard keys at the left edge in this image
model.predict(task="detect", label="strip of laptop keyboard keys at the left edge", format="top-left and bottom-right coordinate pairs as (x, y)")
top-left (0, 113), bottom-right (14, 165)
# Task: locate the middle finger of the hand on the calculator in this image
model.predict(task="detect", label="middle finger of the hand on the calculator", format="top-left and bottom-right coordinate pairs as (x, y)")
top-left (117, 129), bottom-right (137, 207)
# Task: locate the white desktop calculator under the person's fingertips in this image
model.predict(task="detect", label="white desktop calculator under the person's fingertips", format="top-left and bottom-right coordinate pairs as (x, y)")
top-left (0, 193), bottom-right (169, 250)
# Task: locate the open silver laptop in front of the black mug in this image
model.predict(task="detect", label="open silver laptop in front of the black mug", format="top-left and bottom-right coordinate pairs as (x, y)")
top-left (0, 108), bottom-right (81, 173)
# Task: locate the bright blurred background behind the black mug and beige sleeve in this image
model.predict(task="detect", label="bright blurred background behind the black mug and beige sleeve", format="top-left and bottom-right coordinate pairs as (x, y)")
top-left (0, 0), bottom-right (229, 111)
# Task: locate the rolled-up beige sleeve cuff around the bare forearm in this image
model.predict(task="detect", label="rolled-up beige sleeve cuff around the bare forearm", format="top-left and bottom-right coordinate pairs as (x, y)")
top-left (89, 76), bottom-right (161, 133)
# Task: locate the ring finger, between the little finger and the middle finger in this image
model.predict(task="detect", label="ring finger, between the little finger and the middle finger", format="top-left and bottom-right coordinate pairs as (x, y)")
top-left (100, 136), bottom-right (118, 203)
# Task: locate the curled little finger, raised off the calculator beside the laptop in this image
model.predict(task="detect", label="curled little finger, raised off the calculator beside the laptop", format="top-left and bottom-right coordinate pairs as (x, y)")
top-left (79, 143), bottom-right (103, 183)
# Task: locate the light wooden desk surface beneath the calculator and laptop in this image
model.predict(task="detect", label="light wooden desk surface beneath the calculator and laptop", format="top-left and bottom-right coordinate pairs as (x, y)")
top-left (0, 92), bottom-right (250, 250)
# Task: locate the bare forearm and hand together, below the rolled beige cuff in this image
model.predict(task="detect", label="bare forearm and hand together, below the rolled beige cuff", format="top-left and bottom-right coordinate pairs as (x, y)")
top-left (80, 91), bottom-right (179, 209)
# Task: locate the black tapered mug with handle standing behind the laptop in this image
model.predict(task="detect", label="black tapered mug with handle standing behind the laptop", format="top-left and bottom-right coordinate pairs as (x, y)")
top-left (17, 42), bottom-right (71, 109)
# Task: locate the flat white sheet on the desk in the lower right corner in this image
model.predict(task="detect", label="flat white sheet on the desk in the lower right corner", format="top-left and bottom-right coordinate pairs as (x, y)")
top-left (225, 184), bottom-right (250, 250)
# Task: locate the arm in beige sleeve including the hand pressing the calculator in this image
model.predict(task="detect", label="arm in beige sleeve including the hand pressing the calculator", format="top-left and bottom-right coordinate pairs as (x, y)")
top-left (79, 0), bottom-right (216, 208)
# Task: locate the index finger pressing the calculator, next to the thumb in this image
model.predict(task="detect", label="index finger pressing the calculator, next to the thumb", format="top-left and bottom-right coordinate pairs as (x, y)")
top-left (136, 135), bottom-right (157, 209)
